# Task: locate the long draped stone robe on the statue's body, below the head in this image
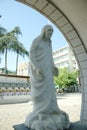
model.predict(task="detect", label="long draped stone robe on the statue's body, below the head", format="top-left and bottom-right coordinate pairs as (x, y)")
top-left (30, 36), bottom-right (58, 113)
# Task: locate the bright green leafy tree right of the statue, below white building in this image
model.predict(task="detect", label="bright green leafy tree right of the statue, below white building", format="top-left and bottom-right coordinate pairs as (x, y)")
top-left (54, 68), bottom-right (78, 88)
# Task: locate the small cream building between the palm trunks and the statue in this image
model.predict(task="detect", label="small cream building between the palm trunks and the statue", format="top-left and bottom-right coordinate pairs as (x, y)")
top-left (17, 62), bottom-right (29, 76)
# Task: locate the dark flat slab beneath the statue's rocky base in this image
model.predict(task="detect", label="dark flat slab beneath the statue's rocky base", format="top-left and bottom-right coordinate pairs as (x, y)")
top-left (13, 123), bottom-right (87, 130)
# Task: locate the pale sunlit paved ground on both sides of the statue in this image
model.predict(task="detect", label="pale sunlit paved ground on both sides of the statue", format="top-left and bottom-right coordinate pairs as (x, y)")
top-left (0, 93), bottom-right (81, 130)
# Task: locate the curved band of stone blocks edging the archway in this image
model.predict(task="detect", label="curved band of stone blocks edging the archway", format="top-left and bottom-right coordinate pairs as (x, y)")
top-left (17, 0), bottom-right (87, 124)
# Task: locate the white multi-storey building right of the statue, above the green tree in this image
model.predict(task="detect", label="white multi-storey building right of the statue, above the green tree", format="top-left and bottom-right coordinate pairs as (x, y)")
top-left (53, 45), bottom-right (78, 70)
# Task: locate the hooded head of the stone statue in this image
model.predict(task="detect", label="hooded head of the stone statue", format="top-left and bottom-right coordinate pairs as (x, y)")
top-left (41, 25), bottom-right (53, 39)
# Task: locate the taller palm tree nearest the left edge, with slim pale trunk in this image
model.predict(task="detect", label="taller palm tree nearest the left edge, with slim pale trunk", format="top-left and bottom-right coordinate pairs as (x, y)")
top-left (0, 26), bottom-right (22, 73)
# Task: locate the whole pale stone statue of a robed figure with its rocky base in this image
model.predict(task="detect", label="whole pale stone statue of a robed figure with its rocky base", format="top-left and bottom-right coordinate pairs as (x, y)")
top-left (25, 25), bottom-right (70, 130)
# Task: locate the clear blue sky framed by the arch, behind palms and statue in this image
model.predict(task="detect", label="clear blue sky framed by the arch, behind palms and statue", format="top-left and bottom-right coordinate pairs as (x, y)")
top-left (0, 0), bottom-right (67, 70)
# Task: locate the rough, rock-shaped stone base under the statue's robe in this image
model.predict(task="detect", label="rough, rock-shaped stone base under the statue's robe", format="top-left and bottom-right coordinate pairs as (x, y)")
top-left (25, 110), bottom-right (70, 130)
